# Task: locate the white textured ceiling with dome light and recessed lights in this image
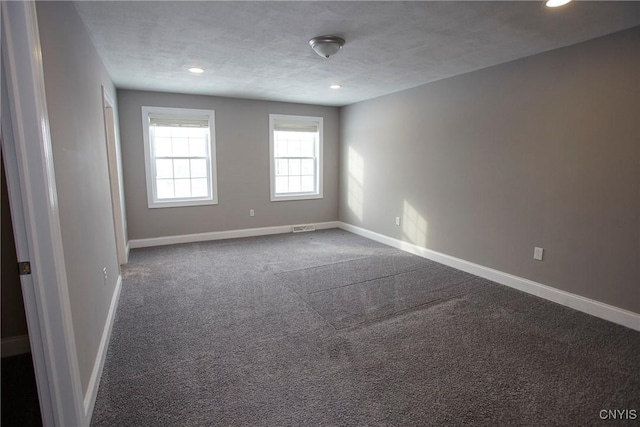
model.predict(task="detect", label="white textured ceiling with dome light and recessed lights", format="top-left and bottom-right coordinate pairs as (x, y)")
top-left (75, 1), bottom-right (640, 106)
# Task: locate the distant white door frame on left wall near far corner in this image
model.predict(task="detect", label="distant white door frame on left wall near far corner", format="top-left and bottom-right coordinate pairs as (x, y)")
top-left (102, 86), bottom-right (129, 265)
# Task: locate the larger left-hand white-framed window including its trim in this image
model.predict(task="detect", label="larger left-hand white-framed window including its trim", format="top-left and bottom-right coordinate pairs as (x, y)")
top-left (142, 107), bottom-right (218, 208)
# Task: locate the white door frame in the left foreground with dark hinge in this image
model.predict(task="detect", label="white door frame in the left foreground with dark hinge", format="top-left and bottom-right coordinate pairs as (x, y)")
top-left (1, 1), bottom-right (88, 427)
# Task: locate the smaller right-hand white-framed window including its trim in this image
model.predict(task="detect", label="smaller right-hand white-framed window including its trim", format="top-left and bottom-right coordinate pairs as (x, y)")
top-left (269, 114), bottom-right (322, 202)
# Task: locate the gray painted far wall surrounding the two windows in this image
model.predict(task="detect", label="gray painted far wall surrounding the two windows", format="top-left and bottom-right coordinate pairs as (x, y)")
top-left (118, 90), bottom-right (339, 239)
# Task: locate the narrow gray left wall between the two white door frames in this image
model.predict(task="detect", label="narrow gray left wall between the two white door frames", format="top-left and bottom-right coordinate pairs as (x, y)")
top-left (37, 2), bottom-right (119, 392)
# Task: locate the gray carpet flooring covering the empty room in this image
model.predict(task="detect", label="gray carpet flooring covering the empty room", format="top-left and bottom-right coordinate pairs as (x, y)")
top-left (92, 230), bottom-right (640, 426)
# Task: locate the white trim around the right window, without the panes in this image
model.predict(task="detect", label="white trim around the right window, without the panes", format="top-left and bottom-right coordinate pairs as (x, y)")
top-left (269, 114), bottom-right (324, 202)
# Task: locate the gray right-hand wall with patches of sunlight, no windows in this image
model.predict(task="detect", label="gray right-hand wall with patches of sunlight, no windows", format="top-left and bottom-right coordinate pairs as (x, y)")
top-left (340, 28), bottom-right (640, 313)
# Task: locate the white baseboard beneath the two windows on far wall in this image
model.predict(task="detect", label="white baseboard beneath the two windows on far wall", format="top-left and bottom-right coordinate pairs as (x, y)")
top-left (129, 221), bottom-right (340, 249)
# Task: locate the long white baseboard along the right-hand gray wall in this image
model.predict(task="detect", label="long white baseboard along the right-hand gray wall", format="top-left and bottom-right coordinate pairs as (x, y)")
top-left (338, 222), bottom-right (640, 331)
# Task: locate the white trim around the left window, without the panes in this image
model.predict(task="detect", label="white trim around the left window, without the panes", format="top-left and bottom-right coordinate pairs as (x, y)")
top-left (142, 106), bottom-right (218, 209)
